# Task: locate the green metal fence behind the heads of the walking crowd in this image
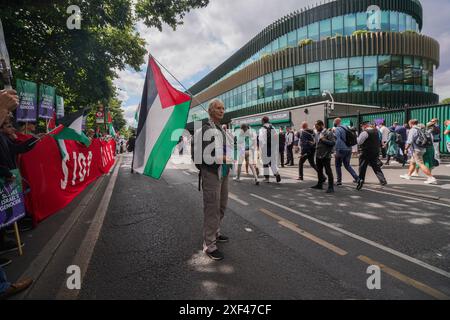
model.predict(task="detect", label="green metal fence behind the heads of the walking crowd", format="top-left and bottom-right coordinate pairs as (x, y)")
top-left (327, 104), bottom-right (450, 154)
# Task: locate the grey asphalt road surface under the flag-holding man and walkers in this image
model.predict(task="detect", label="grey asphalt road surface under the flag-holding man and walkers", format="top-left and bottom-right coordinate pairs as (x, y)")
top-left (6, 154), bottom-right (450, 300)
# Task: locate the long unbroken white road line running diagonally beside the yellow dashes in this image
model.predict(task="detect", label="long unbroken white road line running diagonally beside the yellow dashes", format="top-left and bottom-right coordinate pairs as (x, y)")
top-left (250, 193), bottom-right (450, 279)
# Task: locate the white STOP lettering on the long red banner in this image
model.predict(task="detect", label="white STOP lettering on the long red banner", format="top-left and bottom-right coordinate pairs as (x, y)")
top-left (61, 151), bottom-right (93, 190)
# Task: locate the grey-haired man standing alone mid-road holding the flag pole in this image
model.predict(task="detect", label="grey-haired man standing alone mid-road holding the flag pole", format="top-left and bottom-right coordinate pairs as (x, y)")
top-left (192, 99), bottom-right (233, 260)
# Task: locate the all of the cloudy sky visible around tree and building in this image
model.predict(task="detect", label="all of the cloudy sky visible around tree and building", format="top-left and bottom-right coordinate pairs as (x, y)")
top-left (116, 0), bottom-right (450, 123)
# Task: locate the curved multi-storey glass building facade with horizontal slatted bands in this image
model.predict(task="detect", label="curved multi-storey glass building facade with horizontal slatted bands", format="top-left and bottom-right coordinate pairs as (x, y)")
top-left (188, 0), bottom-right (439, 122)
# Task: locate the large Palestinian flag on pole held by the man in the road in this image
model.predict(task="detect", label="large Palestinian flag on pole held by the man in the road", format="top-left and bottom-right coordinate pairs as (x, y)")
top-left (133, 56), bottom-right (192, 179)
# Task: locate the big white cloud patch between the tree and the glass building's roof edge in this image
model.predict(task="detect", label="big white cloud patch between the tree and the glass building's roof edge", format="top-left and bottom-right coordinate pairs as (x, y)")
top-left (134, 0), bottom-right (312, 87)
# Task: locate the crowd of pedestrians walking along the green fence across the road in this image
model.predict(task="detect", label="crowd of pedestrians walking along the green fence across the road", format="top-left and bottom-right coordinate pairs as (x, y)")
top-left (224, 117), bottom-right (450, 193)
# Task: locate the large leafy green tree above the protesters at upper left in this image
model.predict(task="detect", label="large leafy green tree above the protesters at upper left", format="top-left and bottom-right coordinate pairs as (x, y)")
top-left (0, 0), bottom-right (209, 112)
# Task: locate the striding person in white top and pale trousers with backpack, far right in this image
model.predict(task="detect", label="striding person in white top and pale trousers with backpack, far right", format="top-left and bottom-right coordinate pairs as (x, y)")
top-left (400, 119), bottom-right (437, 184)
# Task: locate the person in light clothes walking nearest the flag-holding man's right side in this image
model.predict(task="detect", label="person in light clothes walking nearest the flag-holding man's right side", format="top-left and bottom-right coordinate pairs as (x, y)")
top-left (234, 124), bottom-right (259, 185)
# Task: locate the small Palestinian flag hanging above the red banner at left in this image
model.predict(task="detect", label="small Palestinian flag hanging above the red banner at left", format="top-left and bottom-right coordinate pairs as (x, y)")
top-left (50, 109), bottom-right (91, 147)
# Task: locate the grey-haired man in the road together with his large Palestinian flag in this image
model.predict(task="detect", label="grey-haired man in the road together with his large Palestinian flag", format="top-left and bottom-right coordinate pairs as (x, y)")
top-left (132, 56), bottom-right (231, 260)
